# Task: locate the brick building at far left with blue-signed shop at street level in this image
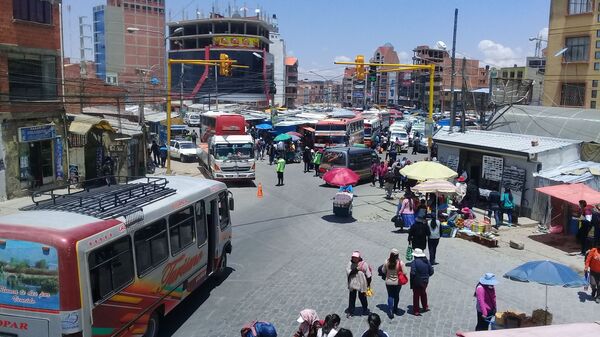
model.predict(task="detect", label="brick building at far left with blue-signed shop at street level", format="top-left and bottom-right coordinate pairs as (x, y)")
top-left (0, 0), bottom-right (67, 200)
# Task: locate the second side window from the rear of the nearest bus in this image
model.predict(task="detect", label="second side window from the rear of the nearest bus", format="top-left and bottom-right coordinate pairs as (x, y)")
top-left (133, 219), bottom-right (169, 276)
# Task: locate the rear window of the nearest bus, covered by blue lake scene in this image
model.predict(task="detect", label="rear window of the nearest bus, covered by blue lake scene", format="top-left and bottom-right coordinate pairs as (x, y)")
top-left (0, 238), bottom-right (60, 310)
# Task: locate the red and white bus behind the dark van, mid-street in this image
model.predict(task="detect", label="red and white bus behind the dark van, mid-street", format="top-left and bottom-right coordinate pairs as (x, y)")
top-left (315, 116), bottom-right (365, 148)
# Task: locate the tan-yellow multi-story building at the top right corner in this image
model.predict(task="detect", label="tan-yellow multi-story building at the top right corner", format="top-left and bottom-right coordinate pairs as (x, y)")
top-left (543, 0), bottom-right (600, 109)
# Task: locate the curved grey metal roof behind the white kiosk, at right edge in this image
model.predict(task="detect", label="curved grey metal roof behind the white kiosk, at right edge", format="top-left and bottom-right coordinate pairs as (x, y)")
top-left (488, 105), bottom-right (600, 142)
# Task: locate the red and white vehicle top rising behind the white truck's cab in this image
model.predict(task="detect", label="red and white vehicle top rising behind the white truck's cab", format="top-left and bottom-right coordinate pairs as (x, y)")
top-left (200, 111), bottom-right (246, 143)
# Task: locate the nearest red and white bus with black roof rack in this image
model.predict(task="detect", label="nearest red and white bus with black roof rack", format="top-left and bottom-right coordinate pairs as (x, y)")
top-left (0, 176), bottom-right (233, 337)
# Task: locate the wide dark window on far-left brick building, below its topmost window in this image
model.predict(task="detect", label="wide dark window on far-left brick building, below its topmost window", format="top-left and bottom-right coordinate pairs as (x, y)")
top-left (8, 54), bottom-right (57, 100)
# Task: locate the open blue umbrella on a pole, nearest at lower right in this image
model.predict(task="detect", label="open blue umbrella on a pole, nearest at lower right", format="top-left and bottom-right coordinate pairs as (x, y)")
top-left (504, 261), bottom-right (587, 320)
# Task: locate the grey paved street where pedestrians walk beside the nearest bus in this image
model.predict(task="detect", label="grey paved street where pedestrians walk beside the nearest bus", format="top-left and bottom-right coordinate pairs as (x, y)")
top-left (161, 156), bottom-right (600, 337)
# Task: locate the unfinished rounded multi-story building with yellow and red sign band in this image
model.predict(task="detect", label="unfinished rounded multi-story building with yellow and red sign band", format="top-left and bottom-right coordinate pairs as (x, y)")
top-left (167, 12), bottom-right (274, 106)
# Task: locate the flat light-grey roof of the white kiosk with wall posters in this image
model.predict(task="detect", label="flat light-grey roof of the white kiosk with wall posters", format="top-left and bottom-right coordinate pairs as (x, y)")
top-left (433, 129), bottom-right (581, 154)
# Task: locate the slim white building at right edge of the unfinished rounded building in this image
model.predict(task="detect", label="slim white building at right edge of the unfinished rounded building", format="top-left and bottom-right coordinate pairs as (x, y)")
top-left (269, 15), bottom-right (287, 106)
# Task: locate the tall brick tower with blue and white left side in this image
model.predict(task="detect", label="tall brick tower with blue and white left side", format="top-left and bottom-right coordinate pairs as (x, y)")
top-left (92, 0), bottom-right (165, 88)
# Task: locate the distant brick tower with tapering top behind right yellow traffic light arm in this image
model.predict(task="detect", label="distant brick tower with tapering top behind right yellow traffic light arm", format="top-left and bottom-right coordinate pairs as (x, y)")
top-left (367, 43), bottom-right (400, 106)
